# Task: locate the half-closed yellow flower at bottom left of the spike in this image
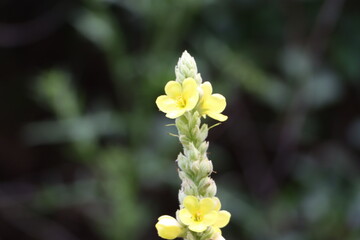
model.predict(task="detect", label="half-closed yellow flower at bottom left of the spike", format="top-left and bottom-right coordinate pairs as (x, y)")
top-left (155, 215), bottom-right (184, 239)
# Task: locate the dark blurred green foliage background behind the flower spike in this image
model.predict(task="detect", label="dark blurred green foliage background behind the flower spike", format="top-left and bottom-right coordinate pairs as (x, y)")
top-left (0, 0), bottom-right (360, 240)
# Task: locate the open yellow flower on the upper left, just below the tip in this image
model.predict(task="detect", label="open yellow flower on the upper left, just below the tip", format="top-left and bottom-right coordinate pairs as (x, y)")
top-left (156, 78), bottom-right (199, 119)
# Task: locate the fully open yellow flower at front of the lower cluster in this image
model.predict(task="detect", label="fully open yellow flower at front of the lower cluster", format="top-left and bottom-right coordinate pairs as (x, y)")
top-left (179, 196), bottom-right (219, 232)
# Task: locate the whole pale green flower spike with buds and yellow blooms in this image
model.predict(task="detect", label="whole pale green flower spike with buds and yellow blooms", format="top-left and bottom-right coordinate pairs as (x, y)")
top-left (156, 51), bottom-right (230, 240)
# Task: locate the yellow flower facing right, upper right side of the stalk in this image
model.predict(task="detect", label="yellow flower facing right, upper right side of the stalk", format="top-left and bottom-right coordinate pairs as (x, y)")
top-left (200, 82), bottom-right (228, 122)
